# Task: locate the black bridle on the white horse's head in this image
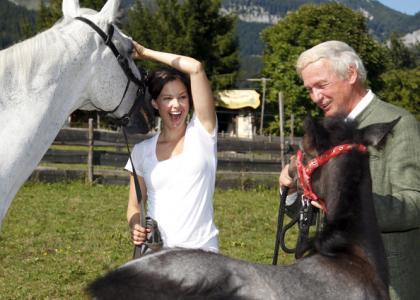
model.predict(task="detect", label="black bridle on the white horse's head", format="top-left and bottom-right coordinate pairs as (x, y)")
top-left (75, 17), bottom-right (145, 118)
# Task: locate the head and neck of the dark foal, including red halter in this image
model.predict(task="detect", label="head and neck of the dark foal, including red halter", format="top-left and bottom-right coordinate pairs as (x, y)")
top-left (294, 117), bottom-right (399, 284)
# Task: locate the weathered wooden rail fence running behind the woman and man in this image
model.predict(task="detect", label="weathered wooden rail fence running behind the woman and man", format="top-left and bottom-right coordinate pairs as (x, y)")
top-left (32, 126), bottom-right (300, 187)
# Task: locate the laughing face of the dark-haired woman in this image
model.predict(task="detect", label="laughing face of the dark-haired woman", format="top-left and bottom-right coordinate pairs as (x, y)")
top-left (152, 79), bottom-right (190, 128)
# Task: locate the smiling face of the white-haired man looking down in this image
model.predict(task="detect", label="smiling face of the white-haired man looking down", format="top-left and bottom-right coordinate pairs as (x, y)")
top-left (302, 59), bottom-right (355, 117)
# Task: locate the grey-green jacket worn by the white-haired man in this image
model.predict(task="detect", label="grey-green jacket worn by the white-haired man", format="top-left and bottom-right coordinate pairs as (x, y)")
top-left (356, 97), bottom-right (420, 300)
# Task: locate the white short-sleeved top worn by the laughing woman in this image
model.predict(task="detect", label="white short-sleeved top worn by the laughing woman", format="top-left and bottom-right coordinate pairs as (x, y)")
top-left (125, 114), bottom-right (218, 252)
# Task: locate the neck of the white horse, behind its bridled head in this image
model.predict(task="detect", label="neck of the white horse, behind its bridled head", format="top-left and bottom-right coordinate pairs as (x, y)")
top-left (0, 21), bottom-right (96, 226)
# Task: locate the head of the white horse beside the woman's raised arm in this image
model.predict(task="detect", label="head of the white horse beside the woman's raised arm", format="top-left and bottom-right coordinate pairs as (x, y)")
top-left (63, 0), bottom-right (141, 118)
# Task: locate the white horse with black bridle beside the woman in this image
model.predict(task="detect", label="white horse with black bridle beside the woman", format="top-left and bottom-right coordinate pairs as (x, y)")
top-left (0, 0), bottom-right (140, 226)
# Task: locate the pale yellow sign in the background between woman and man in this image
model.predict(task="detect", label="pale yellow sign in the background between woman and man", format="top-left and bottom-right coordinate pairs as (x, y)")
top-left (216, 90), bottom-right (260, 109)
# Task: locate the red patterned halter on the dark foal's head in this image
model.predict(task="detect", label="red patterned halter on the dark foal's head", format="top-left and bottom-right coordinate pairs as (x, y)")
top-left (296, 144), bottom-right (367, 213)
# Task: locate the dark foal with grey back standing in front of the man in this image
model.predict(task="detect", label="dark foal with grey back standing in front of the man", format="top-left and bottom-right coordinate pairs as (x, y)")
top-left (88, 118), bottom-right (398, 300)
